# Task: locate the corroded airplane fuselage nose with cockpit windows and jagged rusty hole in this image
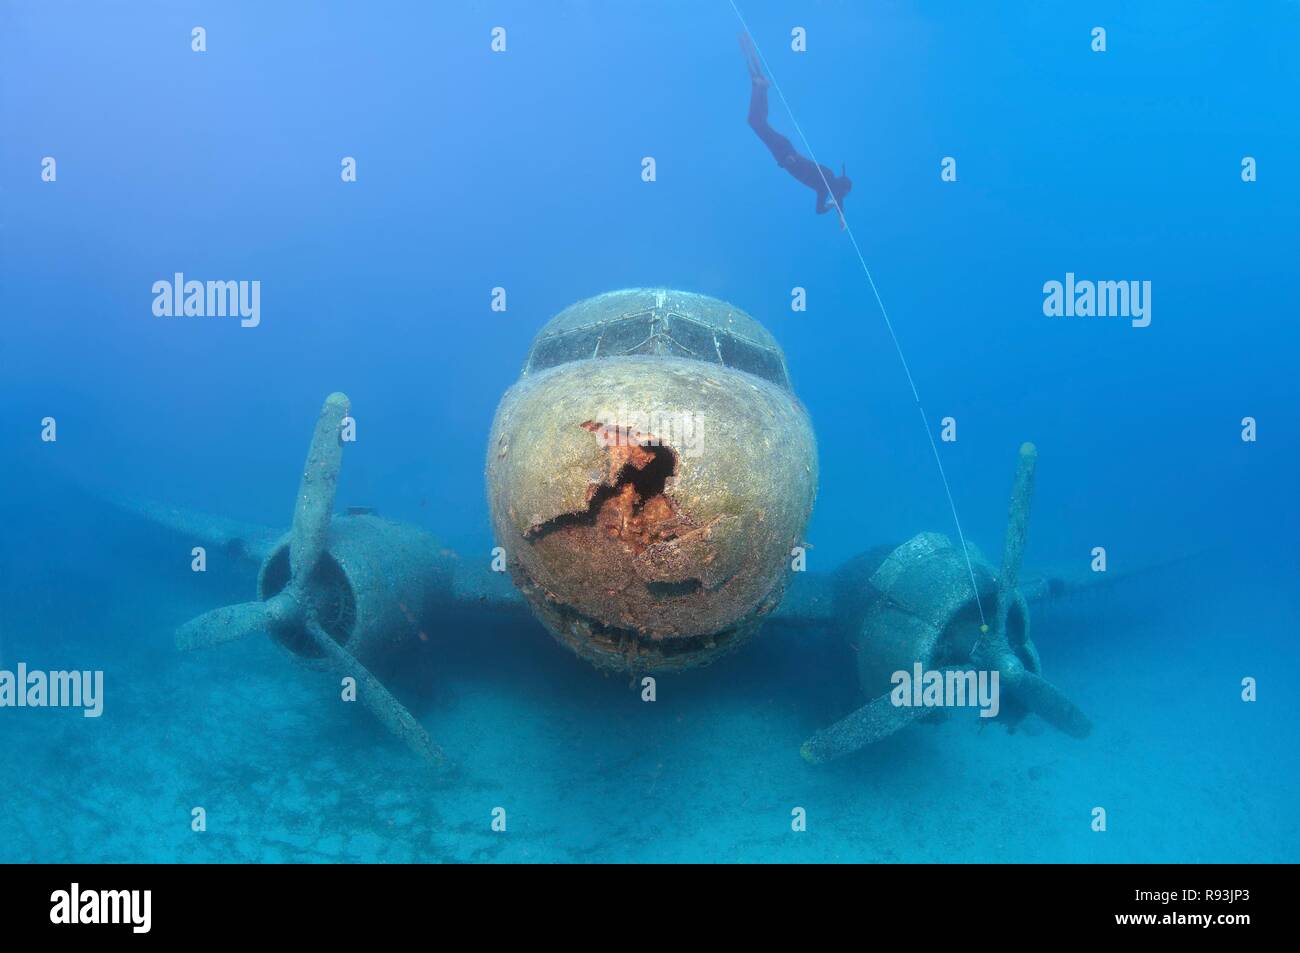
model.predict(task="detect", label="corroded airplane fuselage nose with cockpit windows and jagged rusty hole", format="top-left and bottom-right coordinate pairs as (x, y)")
top-left (486, 289), bottom-right (818, 673)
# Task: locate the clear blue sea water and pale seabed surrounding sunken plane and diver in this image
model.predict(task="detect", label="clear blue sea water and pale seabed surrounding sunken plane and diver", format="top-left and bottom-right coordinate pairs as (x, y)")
top-left (0, 0), bottom-right (1300, 862)
